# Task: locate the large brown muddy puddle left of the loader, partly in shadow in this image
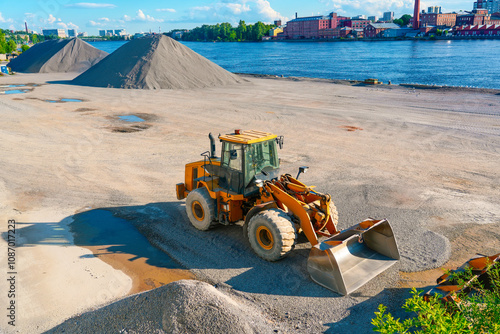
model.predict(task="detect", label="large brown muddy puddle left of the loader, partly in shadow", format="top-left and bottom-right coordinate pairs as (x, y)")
top-left (70, 209), bottom-right (194, 294)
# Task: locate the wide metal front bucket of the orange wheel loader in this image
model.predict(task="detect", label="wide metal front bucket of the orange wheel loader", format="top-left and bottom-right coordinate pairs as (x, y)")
top-left (307, 219), bottom-right (399, 295)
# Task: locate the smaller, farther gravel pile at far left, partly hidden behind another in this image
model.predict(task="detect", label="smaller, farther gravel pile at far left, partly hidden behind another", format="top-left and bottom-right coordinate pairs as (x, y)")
top-left (8, 38), bottom-right (108, 73)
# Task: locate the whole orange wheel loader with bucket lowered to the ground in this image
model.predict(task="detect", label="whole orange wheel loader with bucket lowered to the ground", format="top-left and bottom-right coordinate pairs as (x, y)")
top-left (176, 130), bottom-right (399, 295)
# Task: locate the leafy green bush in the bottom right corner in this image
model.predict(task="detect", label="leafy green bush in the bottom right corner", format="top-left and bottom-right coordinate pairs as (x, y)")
top-left (371, 266), bottom-right (500, 334)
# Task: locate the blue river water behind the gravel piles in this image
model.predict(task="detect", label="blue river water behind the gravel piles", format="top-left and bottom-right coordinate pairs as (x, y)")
top-left (90, 40), bottom-right (500, 89)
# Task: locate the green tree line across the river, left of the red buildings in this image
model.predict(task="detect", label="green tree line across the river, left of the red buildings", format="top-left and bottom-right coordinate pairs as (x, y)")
top-left (178, 21), bottom-right (275, 42)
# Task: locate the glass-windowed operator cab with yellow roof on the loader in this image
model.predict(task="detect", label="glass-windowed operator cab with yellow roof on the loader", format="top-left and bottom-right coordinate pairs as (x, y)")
top-left (219, 130), bottom-right (282, 196)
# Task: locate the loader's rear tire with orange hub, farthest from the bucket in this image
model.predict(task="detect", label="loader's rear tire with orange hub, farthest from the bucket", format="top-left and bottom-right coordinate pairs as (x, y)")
top-left (186, 188), bottom-right (216, 231)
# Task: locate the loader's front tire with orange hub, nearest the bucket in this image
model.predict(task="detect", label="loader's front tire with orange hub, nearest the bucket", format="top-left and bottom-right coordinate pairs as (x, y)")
top-left (248, 209), bottom-right (297, 261)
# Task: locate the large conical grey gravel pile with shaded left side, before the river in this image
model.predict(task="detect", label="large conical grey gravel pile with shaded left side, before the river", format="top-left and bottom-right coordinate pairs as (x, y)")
top-left (72, 35), bottom-right (245, 89)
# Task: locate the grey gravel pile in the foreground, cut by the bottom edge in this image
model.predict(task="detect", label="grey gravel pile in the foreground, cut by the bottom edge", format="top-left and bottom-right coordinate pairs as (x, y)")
top-left (46, 280), bottom-right (275, 334)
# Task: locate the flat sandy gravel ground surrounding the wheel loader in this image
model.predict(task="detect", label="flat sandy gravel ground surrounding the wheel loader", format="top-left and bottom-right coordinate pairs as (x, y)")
top-left (0, 74), bottom-right (500, 333)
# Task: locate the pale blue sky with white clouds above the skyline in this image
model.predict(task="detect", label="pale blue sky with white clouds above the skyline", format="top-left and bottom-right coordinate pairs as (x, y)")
top-left (0, 0), bottom-right (474, 35)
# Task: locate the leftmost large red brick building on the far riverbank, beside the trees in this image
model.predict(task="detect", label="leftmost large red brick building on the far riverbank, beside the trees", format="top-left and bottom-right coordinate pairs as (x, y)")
top-left (283, 13), bottom-right (337, 39)
